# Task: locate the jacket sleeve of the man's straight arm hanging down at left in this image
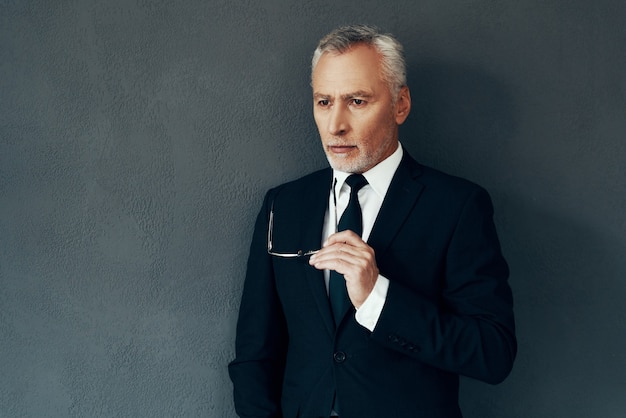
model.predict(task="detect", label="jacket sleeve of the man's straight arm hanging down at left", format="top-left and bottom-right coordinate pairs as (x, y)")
top-left (228, 191), bottom-right (287, 418)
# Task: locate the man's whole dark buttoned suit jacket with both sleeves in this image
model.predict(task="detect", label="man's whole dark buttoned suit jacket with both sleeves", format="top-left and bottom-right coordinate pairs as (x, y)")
top-left (229, 152), bottom-right (516, 418)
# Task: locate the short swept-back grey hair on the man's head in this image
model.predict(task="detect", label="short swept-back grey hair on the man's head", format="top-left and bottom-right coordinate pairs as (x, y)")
top-left (311, 25), bottom-right (406, 96)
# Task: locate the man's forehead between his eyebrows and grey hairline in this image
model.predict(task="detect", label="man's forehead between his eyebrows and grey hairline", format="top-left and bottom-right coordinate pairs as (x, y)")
top-left (312, 45), bottom-right (384, 93)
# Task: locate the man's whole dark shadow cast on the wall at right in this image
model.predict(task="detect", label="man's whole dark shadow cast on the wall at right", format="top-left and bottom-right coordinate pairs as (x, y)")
top-left (401, 61), bottom-right (626, 418)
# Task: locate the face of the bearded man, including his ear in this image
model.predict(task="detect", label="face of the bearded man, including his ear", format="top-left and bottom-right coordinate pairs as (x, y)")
top-left (312, 45), bottom-right (411, 173)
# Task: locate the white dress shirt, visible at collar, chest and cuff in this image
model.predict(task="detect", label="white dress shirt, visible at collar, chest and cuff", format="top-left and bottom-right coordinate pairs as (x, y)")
top-left (322, 145), bottom-right (403, 331)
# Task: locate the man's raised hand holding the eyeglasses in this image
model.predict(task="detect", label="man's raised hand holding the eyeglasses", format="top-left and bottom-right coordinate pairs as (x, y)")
top-left (309, 231), bottom-right (378, 309)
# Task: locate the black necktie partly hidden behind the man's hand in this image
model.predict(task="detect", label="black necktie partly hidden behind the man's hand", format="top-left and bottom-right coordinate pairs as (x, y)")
top-left (328, 174), bottom-right (367, 326)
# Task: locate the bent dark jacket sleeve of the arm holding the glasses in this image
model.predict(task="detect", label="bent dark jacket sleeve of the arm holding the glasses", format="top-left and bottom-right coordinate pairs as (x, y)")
top-left (372, 188), bottom-right (517, 384)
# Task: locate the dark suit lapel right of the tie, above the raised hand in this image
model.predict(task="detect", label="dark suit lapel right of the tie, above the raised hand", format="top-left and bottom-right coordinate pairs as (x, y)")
top-left (368, 152), bottom-right (424, 258)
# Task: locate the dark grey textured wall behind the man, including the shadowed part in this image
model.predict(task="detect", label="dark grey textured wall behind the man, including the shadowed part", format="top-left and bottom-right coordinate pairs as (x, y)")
top-left (0, 0), bottom-right (626, 418)
